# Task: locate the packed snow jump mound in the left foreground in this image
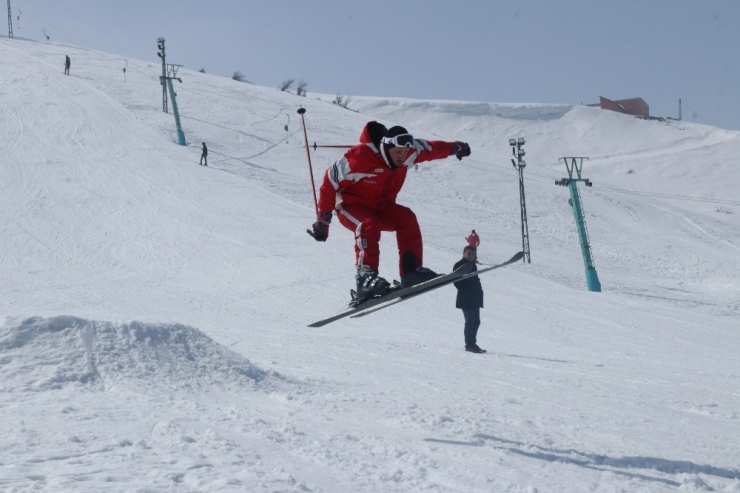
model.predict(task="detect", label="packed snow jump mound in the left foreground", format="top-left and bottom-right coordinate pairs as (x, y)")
top-left (0, 316), bottom-right (268, 391)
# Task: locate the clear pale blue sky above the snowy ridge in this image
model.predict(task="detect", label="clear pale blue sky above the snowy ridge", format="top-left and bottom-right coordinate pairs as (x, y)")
top-left (10, 0), bottom-right (740, 130)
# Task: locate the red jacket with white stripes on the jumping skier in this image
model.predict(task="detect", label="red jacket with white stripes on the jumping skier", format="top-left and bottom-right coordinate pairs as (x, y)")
top-left (319, 124), bottom-right (453, 214)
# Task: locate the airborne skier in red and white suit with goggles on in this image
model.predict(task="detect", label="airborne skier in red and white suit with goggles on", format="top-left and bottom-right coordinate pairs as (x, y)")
top-left (309, 122), bottom-right (470, 300)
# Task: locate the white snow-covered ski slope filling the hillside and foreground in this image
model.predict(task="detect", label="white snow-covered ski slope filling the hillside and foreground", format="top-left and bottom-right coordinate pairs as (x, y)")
top-left (0, 39), bottom-right (740, 493)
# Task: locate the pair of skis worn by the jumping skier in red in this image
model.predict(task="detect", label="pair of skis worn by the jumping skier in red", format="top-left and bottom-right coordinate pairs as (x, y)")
top-left (309, 252), bottom-right (524, 327)
